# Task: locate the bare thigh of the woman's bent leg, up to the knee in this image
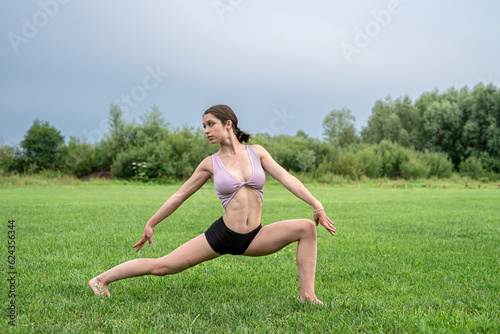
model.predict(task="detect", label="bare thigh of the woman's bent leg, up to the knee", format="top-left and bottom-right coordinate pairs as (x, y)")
top-left (243, 219), bottom-right (316, 256)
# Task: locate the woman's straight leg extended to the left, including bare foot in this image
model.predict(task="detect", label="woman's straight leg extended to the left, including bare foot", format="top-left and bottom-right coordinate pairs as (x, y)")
top-left (89, 234), bottom-right (220, 297)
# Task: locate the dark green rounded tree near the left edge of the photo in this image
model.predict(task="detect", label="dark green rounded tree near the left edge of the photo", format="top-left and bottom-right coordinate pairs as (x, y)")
top-left (21, 118), bottom-right (64, 172)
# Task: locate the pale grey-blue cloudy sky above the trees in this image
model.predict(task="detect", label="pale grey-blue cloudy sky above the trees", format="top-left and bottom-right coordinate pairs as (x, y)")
top-left (0, 0), bottom-right (500, 145)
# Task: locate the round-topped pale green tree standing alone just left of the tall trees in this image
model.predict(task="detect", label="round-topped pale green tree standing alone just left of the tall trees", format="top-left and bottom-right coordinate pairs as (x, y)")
top-left (323, 108), bottom-right (359, 147)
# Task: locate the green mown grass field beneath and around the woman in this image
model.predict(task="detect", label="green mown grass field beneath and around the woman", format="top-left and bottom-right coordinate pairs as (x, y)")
top-left (0, 184), bottom-right (500, 333)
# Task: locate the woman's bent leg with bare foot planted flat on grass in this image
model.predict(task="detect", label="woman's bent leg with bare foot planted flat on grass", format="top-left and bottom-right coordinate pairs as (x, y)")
top-left (243, 219), bottom-right (323, 304)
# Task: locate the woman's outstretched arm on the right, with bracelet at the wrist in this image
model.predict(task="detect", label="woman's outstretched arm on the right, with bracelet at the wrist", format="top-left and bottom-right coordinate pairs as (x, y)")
top-left (252, 145), bottom-right (335, 235)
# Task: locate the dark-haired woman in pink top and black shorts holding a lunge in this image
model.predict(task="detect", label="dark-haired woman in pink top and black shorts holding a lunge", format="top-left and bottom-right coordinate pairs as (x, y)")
top-left (89, 105), bottom-right (335, 304)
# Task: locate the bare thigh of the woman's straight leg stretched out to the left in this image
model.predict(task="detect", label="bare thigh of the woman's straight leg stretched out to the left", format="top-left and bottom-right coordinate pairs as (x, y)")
top-left (157, 234), bottom-right (221, 274)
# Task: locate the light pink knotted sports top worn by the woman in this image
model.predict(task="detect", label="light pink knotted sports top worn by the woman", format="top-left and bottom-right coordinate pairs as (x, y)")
top-left (212, 145), bottom-right (266, 209)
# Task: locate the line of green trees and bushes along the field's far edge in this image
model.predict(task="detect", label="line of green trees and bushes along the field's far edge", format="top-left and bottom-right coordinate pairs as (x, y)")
top-left (0, 84), bottom-right (500, 182)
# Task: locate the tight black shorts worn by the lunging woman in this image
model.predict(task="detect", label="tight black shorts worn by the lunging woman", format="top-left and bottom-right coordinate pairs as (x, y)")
top-left (205, 217), bottom-right (262, 255)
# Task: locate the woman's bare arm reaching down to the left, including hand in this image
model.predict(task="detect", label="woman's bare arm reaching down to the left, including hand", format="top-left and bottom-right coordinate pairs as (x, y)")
top-left (134, 156), bottom-right (212, 252)
